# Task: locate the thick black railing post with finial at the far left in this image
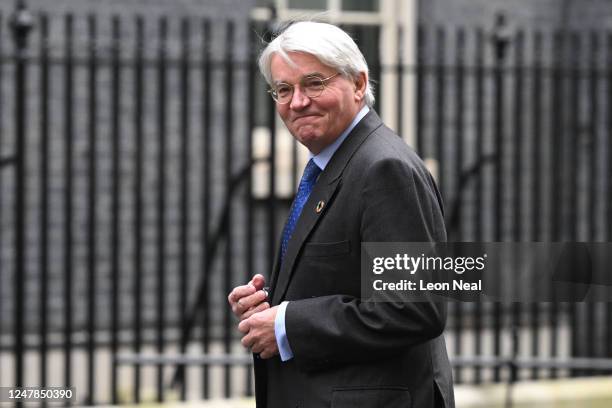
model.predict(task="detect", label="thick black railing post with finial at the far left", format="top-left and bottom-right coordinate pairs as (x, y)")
top-left (10, 0), bottom-right (34, 387)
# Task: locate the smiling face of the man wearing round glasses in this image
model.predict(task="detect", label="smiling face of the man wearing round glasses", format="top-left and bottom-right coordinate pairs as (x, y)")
top-left (271, 52), bottom-right (366, 154)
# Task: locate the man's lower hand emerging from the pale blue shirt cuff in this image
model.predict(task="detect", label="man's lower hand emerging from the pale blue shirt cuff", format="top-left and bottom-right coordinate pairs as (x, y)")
top-left (238, 306), bottom-right (278, 359)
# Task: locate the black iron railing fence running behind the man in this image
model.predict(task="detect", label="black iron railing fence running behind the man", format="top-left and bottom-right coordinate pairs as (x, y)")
top-left (0, 2), bottom-right (612, 404)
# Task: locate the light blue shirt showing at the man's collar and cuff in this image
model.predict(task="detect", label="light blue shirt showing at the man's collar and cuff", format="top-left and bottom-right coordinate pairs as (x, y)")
top-left (274, 105), bottom-right (370, 361)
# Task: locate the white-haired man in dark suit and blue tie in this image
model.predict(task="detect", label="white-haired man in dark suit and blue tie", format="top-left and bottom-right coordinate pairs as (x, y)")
top-left (228, 22), bottom-right (454, 408)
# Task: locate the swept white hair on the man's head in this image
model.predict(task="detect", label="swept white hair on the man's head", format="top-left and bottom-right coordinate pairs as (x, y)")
top-left (259, 21), bottom-right (374, 107)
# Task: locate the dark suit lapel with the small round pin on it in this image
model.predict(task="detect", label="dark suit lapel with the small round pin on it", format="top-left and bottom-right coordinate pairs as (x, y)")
top-left (270, 109), bottom-right (382, 305)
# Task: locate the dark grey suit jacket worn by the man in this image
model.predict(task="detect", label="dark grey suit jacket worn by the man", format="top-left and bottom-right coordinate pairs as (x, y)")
top-left (255, 110), bottom-right (454, 408)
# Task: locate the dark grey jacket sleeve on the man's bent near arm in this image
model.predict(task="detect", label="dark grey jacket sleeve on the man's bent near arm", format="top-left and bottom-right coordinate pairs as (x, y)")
top-left (285, 159), bottom-right (446, 371)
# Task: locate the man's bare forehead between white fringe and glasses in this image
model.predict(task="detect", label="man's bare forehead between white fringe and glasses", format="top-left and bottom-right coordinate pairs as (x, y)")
top-left (270, 52), bottom-right (334, 82)
